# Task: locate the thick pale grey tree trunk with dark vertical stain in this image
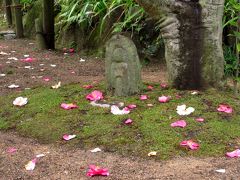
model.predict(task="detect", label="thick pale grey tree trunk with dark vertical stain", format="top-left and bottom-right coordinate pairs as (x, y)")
top-left (136, 0), bottom-right (224, 89)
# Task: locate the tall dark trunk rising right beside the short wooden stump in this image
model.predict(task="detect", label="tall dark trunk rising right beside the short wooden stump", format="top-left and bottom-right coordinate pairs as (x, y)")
top-left (43, 0), bottom-right (55, 49)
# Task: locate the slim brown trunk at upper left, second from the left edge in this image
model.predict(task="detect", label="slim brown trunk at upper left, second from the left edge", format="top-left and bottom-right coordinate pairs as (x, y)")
top-left (13, 0), bottom-right (24, 38)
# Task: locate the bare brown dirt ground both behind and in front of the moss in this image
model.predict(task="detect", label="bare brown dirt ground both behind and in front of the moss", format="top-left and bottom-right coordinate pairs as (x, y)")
top-left (0, 40), bottom-right (240, 180)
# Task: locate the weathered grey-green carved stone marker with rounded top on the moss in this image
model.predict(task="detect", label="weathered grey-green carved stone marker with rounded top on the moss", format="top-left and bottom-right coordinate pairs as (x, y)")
top-left (105, 34), bottom-right (142, 96)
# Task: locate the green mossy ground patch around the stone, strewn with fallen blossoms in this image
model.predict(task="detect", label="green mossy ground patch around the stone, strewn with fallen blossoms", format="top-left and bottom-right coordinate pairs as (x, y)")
top-left (0, 84), bottom-right (240, 159)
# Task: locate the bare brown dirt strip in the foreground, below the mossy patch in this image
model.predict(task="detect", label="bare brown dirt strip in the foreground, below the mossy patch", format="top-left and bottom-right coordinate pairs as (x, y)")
top-left (0, 132), bottom-right (240, 180)
